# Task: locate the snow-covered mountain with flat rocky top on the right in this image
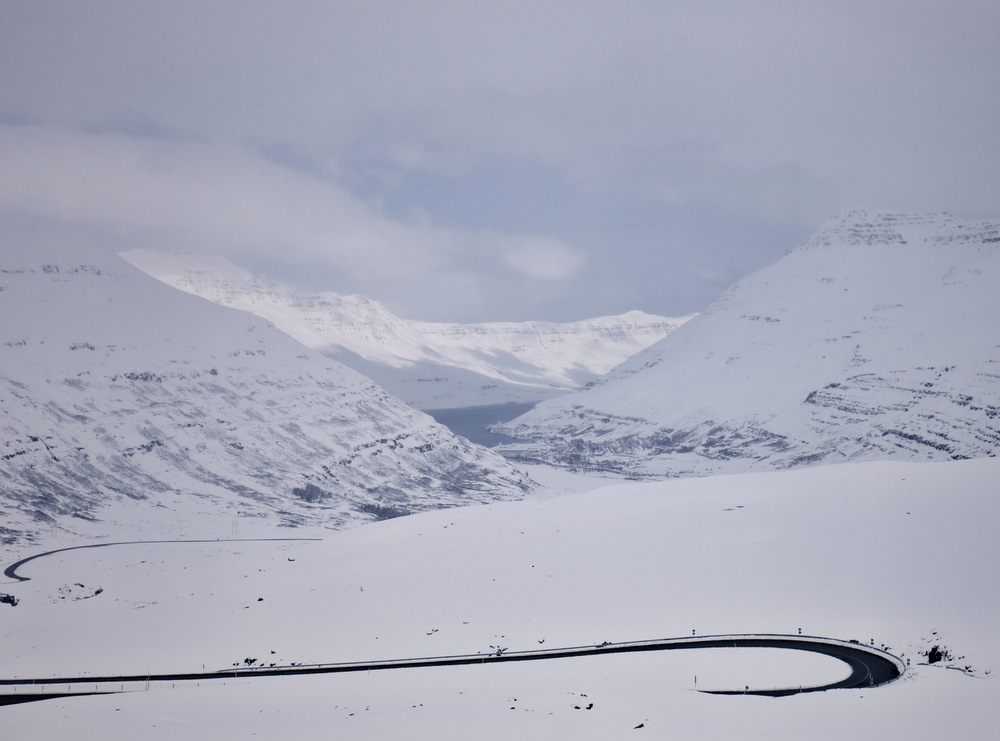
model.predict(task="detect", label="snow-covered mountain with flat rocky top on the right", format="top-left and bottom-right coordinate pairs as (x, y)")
top-left (502, 210), bottom-right (1000, 475)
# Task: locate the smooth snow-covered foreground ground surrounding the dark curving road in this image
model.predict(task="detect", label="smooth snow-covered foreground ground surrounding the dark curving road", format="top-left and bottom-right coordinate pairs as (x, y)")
top-left (0, 459), bottom-right (1000, 741)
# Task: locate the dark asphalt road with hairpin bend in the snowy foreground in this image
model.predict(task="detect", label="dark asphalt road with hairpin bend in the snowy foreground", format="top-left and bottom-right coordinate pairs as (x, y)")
top-left (0, 635), bottom-right (905, 705)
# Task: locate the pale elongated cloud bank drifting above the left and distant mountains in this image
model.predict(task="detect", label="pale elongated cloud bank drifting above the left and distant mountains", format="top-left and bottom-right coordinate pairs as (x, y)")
top-left (0, 126), bottom-right (582, 318)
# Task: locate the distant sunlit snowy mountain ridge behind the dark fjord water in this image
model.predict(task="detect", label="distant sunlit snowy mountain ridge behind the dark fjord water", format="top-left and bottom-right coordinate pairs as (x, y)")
top-left (122, 250), bottom-right (690, 409)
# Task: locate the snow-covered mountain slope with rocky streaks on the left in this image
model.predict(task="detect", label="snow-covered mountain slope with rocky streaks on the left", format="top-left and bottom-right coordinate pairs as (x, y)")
top-left (0, 244), bottom-right (530, 538)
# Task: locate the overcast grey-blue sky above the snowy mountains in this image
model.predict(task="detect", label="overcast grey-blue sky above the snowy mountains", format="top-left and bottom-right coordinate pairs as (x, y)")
top-left (0, 0), bottom-right (1000, 321)
